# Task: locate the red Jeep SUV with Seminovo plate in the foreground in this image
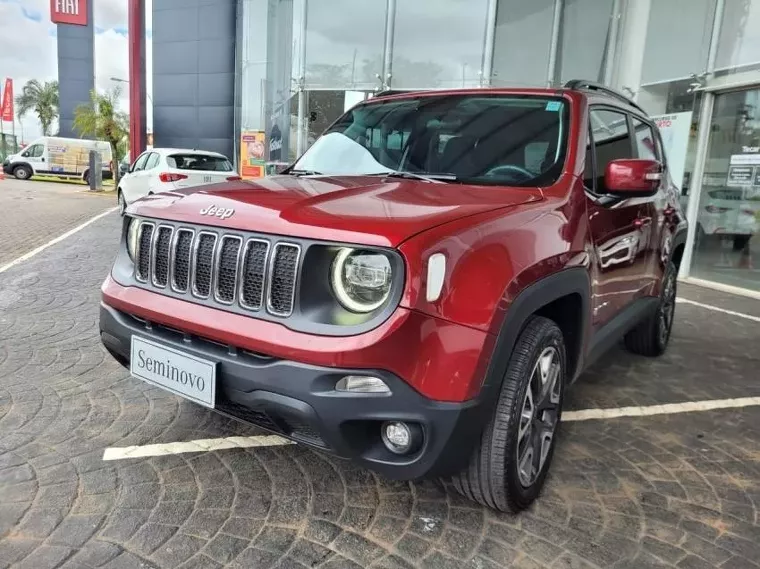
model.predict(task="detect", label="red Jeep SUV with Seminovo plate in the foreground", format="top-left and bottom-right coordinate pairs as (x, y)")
top-left (100, 81), bottom-right (686, 511)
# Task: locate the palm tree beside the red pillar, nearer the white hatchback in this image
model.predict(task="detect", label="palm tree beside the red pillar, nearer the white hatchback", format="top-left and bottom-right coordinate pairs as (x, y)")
top-left (74, 87), bottom-right (129, 187)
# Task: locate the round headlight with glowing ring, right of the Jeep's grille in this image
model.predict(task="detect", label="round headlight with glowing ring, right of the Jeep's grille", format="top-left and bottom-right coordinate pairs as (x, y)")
top-left (331, 248), bottom-right (391, 312)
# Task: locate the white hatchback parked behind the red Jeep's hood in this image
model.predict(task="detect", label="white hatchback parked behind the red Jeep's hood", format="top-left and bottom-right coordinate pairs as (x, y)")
top-left (118, 148), bottom-right (240, 215)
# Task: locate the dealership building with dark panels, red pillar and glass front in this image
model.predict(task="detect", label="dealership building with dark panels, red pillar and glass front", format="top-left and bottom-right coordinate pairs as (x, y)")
top-left (52, 0), bottom-right (760, 295)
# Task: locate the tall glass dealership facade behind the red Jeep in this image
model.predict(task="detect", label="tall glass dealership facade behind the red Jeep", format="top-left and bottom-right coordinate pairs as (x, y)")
top-left (235, 0), bottom-right (760, 298)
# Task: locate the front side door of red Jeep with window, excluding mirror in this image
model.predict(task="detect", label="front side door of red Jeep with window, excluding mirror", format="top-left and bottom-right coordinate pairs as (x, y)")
top-left (584, 108), bottom-right (657, 327)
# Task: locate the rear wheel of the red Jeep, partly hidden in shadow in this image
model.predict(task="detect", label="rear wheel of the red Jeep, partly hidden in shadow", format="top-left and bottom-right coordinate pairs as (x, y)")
top-left (625, 261), bottom-right (678, 357)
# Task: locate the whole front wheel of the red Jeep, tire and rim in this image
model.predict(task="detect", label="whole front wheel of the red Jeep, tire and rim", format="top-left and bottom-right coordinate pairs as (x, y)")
top-left (453, 316), bottom-right (566, 512)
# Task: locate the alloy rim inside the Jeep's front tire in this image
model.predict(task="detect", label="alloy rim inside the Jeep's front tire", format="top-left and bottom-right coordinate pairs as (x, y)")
top-left (517, 347), bottom-right (562, 488)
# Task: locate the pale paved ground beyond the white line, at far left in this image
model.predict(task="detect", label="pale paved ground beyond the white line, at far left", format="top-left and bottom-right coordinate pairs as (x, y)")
top-left (0, 177), bottom-right (116, 267)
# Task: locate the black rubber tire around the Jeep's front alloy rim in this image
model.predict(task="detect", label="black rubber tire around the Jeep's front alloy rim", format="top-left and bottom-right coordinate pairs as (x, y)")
top-left (452, 316), bottom-right (567, 512)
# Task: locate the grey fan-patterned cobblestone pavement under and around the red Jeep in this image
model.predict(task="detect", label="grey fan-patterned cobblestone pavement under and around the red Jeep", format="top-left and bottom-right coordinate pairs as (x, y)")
top-left (0, 213), bottom-right (760, 569)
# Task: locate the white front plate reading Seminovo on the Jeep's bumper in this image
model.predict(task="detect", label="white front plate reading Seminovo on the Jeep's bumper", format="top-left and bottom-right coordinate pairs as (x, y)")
top-left (129, 336), bottom-right (217, 409)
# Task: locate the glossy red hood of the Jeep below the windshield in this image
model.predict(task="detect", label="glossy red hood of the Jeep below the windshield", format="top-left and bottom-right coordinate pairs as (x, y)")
top-left (129, 176), bottom-right (542, 247)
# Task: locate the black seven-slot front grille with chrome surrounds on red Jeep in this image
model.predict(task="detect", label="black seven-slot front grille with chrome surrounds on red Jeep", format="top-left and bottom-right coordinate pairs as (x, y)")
top-left (135, 221), bottom-right (301, 318)
